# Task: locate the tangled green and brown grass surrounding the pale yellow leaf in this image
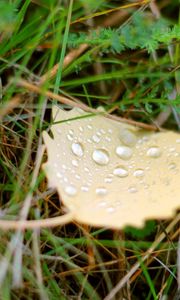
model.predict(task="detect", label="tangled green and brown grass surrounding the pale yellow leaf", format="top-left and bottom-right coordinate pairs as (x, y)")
top-left (0, 0), bottom-right (180, 300)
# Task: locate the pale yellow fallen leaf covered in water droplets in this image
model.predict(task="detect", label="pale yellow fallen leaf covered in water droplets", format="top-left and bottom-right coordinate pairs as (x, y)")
top-left (43, 106), bottom-right (180, 228)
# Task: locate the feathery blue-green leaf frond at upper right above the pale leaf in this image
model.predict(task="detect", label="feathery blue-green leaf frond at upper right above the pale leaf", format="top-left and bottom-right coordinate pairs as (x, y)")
top-left (68, 13), bottom-right (180, 53)
